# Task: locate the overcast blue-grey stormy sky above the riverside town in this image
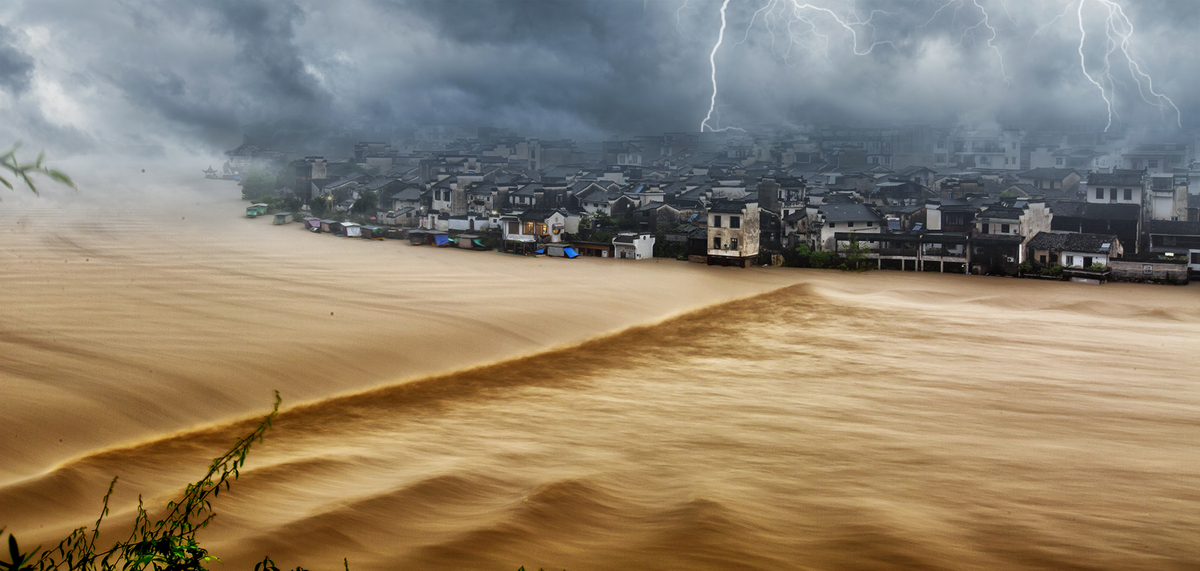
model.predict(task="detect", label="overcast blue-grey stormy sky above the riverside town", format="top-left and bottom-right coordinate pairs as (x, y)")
top-left (0, 0), bottom-right (1200, 154)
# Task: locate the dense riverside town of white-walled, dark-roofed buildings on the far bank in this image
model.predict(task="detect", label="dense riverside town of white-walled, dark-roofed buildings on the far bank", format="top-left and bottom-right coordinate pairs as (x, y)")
top-left (232, 127), bottom-right (1200, 278)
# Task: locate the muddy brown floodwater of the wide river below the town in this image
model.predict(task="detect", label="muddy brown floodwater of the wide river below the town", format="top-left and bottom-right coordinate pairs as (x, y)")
top-left (0, 166), bottom-right (1200, 570)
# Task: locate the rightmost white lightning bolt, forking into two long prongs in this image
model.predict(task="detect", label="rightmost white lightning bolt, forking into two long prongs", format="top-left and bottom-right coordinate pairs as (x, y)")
top-left (1076, 0), bottom-right (1183, 131)
